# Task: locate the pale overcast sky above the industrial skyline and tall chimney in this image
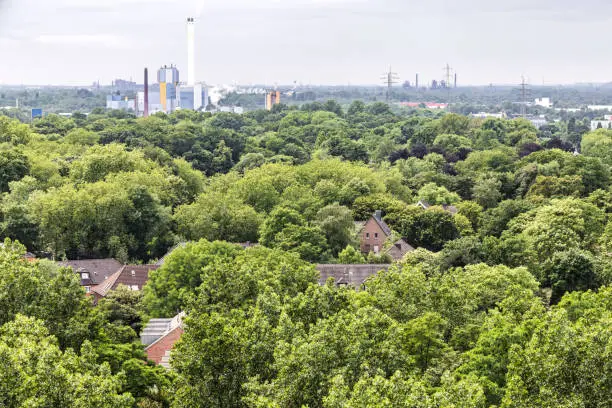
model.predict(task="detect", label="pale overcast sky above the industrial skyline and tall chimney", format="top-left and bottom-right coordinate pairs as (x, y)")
top-left (0, 0), bottom-right (612, 85)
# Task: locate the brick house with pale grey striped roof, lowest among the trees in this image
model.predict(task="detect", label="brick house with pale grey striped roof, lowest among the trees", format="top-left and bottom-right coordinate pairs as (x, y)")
top-left (140, 312), bottom-right (185, 368)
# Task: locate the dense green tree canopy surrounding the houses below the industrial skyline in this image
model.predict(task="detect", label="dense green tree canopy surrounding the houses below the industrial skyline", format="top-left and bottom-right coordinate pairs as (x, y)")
top-left (0, 100), bottom-right (612, 408)
